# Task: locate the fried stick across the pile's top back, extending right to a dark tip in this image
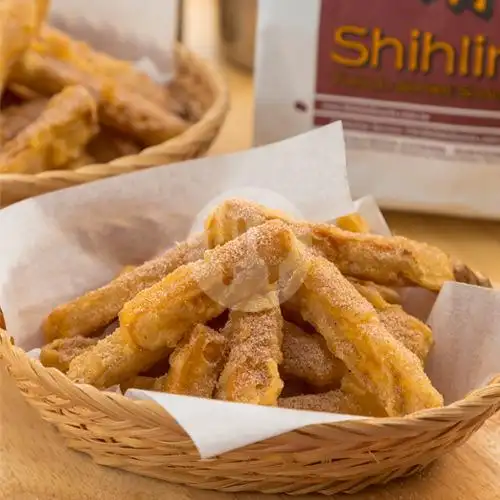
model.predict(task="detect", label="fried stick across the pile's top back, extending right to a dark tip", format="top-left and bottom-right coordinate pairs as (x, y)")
top-left (205, 200), bottom-right (488, 290)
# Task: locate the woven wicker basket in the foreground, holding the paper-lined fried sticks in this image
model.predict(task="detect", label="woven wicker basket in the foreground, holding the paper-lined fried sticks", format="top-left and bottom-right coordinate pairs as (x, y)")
top-left (0, 330), bottom-right (500, 495)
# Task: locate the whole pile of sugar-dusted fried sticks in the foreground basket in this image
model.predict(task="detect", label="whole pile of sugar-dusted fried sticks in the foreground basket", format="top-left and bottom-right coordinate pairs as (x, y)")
top-left (41, 200), bottom-right (488, 417)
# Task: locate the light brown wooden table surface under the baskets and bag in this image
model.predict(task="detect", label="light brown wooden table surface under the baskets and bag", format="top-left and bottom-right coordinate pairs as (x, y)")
top-left (0, 0), bottom-right (500, 500)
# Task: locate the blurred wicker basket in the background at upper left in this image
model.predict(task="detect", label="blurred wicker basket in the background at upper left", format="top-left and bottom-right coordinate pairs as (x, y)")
top-left (0, 45), bottom-right (229, 207)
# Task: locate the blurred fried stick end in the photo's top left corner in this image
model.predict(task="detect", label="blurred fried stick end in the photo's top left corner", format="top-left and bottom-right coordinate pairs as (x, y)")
top-left (0, 0), bottom-right (47, 94)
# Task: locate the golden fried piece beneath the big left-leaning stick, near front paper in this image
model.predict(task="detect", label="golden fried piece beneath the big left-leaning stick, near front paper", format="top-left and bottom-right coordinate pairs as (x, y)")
top-left (68, 328), bottom-right (172, 389)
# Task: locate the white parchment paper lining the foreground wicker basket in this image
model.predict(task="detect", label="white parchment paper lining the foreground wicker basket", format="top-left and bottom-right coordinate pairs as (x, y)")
top-left (0, 123), bottom-right (500, 458)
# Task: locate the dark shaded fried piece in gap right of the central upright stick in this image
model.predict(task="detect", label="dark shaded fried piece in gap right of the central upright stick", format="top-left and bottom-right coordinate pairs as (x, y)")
top-left (280, 321), bottom-right (346, 387)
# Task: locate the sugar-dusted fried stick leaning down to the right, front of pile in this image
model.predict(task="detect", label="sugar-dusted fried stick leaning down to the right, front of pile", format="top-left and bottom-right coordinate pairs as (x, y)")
top-left (296, 245), bottom-right (443, 416)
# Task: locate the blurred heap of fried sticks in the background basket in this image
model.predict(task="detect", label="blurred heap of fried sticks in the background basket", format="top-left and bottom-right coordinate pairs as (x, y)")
top-left (0, 0), bottom-right (190, 174)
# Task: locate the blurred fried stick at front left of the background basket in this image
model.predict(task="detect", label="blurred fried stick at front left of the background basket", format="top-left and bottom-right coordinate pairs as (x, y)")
top-left (0, 86), bottom-right (98, 173)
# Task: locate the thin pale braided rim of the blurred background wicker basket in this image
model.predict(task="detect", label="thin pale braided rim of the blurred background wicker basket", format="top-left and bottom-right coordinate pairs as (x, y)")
top-left (0, 43), bottom-right (229, 181)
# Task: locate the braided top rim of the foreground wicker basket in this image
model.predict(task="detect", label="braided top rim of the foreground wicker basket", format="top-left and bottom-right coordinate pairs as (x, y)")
top-left (0, 329), bottom-right (500, 442)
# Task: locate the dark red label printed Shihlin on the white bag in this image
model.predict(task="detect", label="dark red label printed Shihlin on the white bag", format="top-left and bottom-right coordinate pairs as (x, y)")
top-left (315, 0), bottom-right (500, 145)
